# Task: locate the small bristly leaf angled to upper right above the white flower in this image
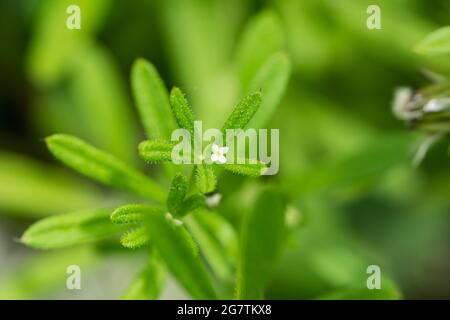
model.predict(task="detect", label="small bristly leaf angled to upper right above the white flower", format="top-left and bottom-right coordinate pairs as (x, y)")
top-left (222, 92), bottom-right (261, 132)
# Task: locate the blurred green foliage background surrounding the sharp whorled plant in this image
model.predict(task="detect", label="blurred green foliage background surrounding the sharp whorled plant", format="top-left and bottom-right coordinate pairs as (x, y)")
top-left (0, 0), bottom-right (450, 299)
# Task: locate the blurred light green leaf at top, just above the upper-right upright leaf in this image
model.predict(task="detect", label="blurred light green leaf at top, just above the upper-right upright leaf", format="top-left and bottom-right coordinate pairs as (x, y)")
top-left (237, 10), bottom-right (284, 91)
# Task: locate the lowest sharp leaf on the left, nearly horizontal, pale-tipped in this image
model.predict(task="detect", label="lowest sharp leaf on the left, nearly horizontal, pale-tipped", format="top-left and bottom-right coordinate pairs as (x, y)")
top-left (21, 210), bottom-right (123, 249)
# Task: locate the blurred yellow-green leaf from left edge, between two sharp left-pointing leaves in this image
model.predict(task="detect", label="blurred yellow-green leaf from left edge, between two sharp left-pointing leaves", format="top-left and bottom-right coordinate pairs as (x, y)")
top-left (0, 152), bottom-right (102, 217)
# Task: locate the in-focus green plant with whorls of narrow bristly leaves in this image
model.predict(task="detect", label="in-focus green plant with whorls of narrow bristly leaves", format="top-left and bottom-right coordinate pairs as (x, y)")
top-left (21, 56), bottom-right (286, 299)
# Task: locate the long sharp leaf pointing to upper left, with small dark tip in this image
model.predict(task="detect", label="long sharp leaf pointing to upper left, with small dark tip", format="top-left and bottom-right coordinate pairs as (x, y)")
top-left (46, 134), bottom-right (165, 202)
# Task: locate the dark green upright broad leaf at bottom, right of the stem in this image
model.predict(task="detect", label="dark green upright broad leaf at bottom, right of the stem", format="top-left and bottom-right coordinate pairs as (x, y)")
top-left (236, 189), bottom-right (285, 299)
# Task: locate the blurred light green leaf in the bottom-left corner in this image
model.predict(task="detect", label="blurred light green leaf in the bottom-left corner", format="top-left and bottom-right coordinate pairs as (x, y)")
top-left (0, 247), bottom-right (100, 300)
